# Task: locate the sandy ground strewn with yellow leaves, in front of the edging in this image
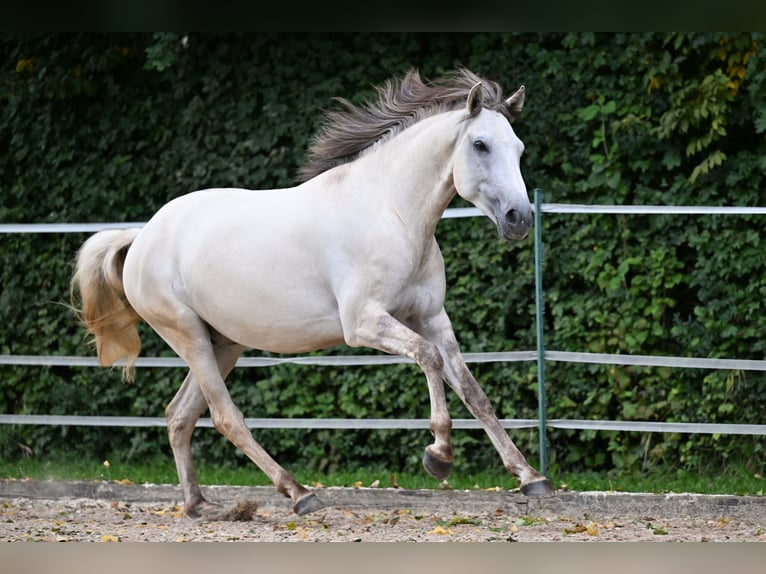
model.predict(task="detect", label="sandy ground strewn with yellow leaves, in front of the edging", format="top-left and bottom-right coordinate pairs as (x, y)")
top-left (0, 486), bottom-right (766, 542)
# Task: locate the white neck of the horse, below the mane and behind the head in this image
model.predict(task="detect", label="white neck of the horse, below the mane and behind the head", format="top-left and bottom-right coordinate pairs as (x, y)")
top-left (369, 112), bottom-right (460, 240)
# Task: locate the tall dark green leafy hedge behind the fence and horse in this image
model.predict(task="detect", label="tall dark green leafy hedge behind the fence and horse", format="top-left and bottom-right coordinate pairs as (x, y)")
top-left (0, 33), bottom-right (766, 482)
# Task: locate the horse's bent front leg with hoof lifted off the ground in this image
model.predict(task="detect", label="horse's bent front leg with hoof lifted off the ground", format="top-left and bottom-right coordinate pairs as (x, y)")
top-left (345, 311), bottom-right (454, 480)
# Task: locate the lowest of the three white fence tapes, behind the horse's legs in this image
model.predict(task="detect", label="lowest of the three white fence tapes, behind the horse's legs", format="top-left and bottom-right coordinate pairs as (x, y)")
top-left (0, 415), bottom-right (766, 435)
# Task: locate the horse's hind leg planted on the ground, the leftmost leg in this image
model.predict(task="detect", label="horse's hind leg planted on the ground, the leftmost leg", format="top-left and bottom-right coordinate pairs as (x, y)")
top-left (165, 343), bottom-right (255, 520)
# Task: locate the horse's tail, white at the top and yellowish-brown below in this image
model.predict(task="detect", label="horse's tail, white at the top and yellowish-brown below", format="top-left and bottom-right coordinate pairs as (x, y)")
top-left (70, 229), bottom-right (141, 381)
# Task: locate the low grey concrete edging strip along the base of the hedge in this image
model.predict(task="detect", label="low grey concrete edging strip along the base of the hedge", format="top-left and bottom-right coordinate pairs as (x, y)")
top-left (0, 480), bottom-right (766, 521)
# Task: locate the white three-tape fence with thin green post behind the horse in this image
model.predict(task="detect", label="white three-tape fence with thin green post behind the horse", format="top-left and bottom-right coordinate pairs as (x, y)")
top-left (0, 190), bottom-right (766, 474)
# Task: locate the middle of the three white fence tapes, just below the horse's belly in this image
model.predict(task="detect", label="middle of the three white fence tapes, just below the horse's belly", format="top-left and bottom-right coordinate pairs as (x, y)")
top-left (6, 351), bottom-right (766, 371)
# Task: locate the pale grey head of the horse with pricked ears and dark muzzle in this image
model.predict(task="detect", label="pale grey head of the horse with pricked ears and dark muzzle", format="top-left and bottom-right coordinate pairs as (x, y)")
top-left (453, 83), bottom-right (532, 241)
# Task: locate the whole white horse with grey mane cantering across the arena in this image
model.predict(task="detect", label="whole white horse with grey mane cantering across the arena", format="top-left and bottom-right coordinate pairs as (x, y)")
top-left (71, 68), bottom-right (554, 520)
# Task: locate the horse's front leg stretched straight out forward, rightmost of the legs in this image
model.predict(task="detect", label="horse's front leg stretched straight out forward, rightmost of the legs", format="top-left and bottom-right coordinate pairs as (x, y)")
top-left (421, 309), bottom-right (554, 496)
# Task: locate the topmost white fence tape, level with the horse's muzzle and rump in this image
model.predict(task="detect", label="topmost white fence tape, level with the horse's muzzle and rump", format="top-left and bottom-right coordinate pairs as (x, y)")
top-left (0, 203), bottom-right (766, 234)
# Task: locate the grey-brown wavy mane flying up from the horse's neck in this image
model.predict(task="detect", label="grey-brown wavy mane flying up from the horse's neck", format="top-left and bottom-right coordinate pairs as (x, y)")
top-left (298, 68), bottom-right (510, 181)
